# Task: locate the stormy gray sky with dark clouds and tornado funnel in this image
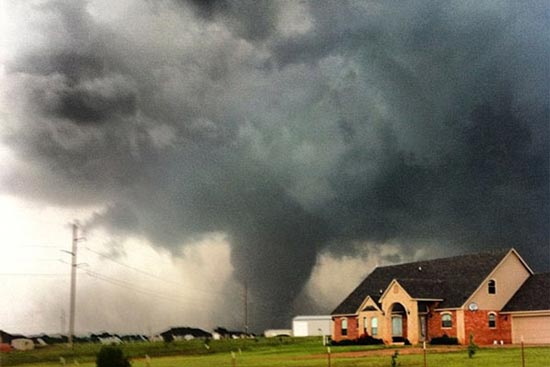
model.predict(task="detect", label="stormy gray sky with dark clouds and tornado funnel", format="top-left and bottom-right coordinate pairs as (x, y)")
top-left (0, 0), bottom-right (550, 331)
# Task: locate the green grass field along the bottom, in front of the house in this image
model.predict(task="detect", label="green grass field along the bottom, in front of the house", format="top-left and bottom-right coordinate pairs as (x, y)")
top-left (0, 338), bottom-right (550, 367)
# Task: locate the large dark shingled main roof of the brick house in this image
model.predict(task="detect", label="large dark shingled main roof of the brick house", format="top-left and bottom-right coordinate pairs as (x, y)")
top-left (332, 249), bottom-right (510, 315)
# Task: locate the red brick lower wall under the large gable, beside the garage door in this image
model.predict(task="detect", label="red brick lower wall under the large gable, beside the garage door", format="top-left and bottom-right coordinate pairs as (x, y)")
top-left (464, 310), bottom-right (512, 344)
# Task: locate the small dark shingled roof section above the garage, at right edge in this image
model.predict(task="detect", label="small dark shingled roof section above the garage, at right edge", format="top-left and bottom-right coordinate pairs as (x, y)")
top-left (502, 273), bottom-right (550, 312)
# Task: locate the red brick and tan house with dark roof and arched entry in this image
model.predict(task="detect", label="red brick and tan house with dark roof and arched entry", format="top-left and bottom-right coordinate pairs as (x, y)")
top-left (331, 249), bottom-right (550, 344)
